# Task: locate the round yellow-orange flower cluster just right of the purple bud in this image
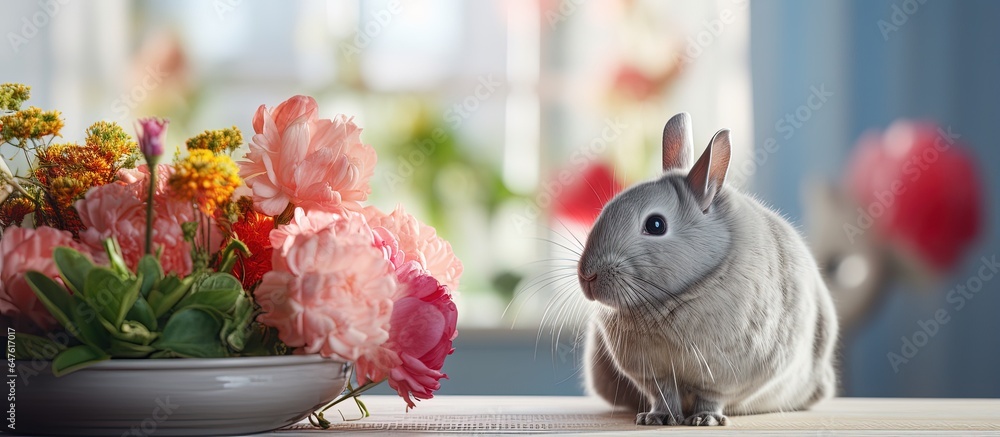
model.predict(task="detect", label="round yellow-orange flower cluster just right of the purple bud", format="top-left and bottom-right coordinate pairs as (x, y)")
top-left (167, 149), bottom-right (242, 214)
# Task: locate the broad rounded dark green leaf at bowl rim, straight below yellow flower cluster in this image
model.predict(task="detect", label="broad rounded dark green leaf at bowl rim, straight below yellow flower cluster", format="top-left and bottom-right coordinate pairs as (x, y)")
top-left (153, 308), bottom-right (226, 358)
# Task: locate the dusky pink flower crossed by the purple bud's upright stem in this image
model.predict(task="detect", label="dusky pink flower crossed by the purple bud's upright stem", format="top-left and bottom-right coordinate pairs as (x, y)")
top-left (76, 182), bottom-right (193, 276)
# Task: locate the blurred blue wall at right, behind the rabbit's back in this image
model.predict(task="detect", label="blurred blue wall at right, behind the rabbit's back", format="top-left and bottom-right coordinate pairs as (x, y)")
top-left (751, 0), bottom-right (1000, 397)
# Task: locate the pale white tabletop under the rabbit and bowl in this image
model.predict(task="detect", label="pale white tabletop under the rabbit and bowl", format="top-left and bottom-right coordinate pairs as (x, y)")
top-left (272, 396), bottom-right (1000, 437)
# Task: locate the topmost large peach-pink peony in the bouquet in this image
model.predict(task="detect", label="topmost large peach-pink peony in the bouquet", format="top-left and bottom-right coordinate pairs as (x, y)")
top-left (239, 96), bottom-right (377, 216)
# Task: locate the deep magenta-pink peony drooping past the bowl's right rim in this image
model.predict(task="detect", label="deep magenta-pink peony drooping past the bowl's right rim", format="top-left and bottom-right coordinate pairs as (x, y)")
top-left (357, 261), bottom-right (458, 408)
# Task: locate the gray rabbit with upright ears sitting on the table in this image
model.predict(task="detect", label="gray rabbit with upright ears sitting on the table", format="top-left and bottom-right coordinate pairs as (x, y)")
top-left (577, 113), bottom-right (837, 426)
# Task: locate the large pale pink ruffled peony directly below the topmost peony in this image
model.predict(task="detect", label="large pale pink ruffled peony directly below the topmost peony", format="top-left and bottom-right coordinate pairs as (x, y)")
top-left (254, 208), bottom-right (396, 360)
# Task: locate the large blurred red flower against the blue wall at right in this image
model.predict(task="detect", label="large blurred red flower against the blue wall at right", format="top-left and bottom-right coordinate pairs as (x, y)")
top-left (847, 120), bottom-right (984, 271)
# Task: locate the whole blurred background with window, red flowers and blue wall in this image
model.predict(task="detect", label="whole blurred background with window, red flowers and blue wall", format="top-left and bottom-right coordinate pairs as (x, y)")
top-left (0, 0), bottom-right (1000, 397)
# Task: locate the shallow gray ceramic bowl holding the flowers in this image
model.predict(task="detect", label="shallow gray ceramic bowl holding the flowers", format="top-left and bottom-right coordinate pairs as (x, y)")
top-left (13, 355), bottom-right (351, 436)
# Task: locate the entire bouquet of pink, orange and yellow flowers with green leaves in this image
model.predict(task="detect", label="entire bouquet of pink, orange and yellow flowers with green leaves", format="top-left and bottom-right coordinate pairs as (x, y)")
top-left (0, 84), bottom-right (462, 425)
